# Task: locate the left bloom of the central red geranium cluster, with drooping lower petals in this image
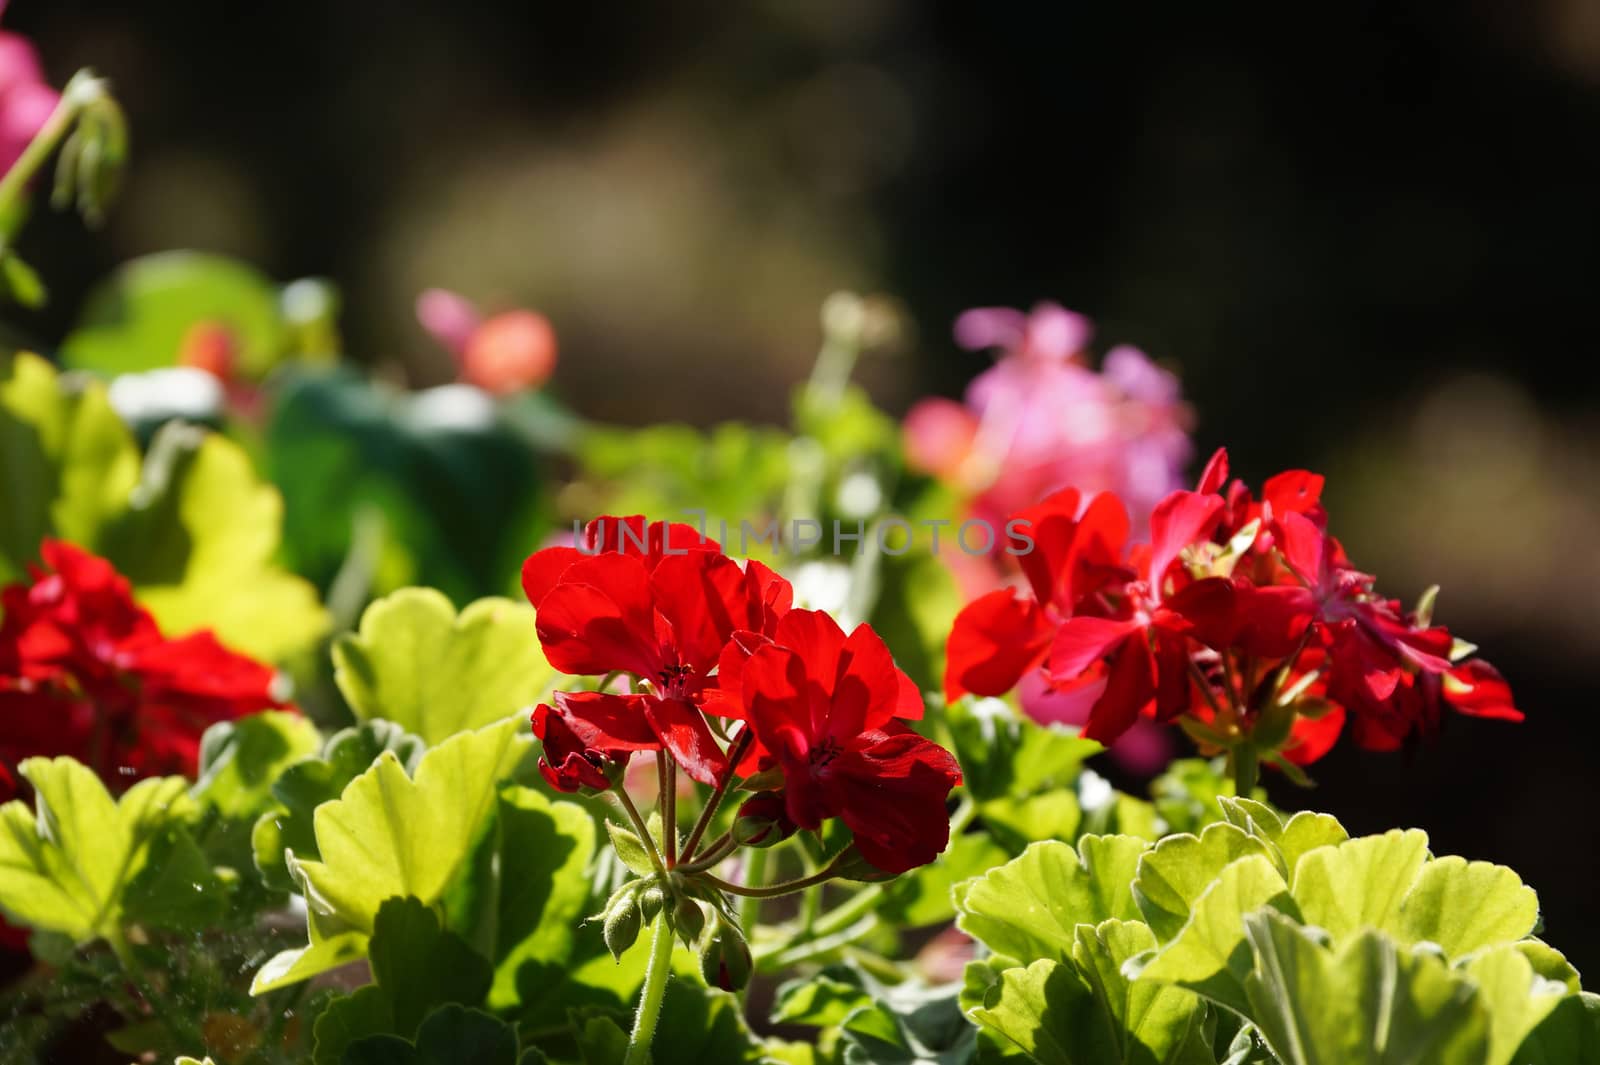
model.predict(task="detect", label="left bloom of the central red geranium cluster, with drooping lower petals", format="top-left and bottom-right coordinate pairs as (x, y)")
top-left (523, 517), bottom-right (794, 784)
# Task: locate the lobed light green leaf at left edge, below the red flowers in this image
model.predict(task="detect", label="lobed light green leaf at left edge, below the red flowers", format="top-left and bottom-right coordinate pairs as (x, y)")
top-left (0, 758), bottom-right (194, 943)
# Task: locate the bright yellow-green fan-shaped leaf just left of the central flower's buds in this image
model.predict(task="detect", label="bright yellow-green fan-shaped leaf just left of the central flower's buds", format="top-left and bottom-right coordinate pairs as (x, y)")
top-left (251, 720), bottom-right (526, 995)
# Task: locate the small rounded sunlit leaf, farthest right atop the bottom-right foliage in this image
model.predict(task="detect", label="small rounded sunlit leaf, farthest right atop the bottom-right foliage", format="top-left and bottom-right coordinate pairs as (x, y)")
top-left (1392, 856), bottom-right (1539, 958)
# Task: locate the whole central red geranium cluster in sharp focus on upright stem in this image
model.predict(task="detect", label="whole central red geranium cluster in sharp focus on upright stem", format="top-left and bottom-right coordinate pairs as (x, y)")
top-left (523, 517), bottom-right (960, 873)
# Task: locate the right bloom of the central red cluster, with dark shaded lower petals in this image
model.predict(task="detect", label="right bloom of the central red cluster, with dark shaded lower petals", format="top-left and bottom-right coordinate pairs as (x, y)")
top-left (741, 611), bottom-right (962, 873)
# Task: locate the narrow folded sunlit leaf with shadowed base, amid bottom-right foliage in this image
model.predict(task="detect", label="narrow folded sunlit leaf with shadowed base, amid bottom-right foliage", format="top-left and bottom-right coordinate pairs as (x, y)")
top-left (1141, 854), bottom-right (1294, 1017)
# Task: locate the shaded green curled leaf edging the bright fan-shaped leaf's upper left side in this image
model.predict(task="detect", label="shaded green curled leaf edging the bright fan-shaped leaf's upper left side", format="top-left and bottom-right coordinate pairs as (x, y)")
top-left (250, 721), bottom-right (427, 891)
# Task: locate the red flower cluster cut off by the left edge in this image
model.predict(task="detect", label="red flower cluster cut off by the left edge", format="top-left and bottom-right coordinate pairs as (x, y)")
top-left (0, 540), bottom-right (283, 798)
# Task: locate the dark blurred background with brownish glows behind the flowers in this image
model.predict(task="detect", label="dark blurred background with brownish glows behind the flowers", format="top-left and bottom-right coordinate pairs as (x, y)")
top-left (6, 0), bottom-right (1600, 975)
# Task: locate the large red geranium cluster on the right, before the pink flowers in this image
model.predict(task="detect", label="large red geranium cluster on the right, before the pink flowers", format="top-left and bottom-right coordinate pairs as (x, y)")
top-left (946, 451), bottom-right (1522, 764)
